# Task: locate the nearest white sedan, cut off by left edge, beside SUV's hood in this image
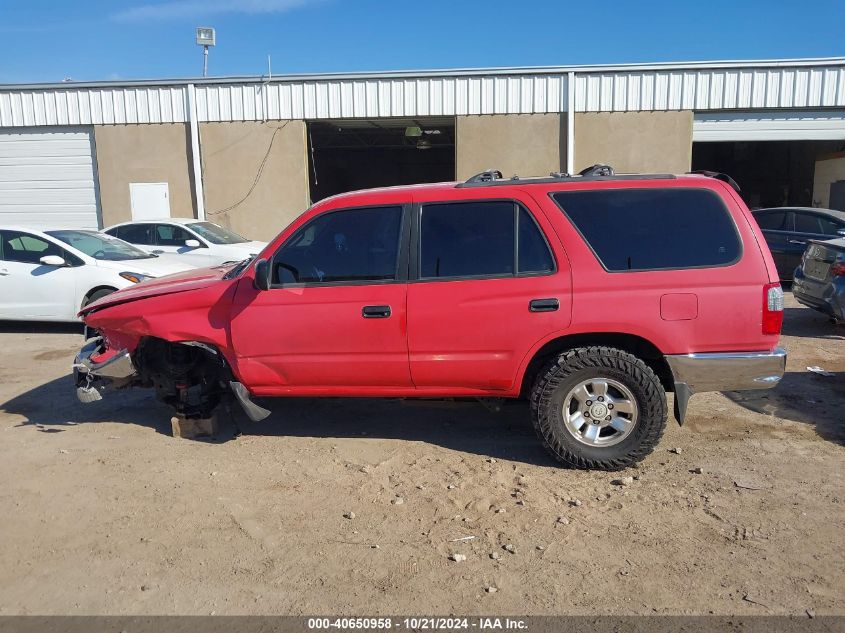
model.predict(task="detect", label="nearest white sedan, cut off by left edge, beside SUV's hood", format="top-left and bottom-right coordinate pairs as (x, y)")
top-left (0, 226), bottom-right (194, 321)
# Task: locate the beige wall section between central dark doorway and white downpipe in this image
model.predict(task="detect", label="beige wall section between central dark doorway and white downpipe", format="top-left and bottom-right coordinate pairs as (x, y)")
top-left (455, 114), bottom-right (566, 180)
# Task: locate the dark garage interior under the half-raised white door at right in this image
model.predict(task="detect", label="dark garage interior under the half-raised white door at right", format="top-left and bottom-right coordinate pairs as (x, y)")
top-left (692, 141), bottom-right (845, 209)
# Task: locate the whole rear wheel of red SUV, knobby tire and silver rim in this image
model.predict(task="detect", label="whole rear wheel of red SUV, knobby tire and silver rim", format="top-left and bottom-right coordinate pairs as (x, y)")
top-left (531, 347), bottom-right (667, 470)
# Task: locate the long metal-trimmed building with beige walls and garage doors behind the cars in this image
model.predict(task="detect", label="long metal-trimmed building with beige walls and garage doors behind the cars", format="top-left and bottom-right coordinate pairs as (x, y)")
top-left (0, 58), bottom-right (845, 238)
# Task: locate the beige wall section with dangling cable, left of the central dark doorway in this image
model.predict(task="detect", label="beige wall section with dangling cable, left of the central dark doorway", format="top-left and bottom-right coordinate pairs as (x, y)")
top-left (200, 121), bottom-right (309, 240)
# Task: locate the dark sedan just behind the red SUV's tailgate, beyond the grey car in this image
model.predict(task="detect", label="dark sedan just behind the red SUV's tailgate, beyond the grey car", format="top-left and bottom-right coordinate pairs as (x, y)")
top-left (752, 207), bottom-right (845, 280)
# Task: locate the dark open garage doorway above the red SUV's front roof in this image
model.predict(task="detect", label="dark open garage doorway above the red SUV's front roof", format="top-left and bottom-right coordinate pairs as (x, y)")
top-left (308, 117), bottom-right (455, 202)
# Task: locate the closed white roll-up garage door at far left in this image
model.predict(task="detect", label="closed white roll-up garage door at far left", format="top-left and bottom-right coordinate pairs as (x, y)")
top-left (0, 127), bottom-right (99, 229)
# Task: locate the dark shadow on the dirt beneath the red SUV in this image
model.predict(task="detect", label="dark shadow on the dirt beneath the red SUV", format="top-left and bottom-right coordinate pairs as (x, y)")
top-left (0, 375), bottom-right (554, 466)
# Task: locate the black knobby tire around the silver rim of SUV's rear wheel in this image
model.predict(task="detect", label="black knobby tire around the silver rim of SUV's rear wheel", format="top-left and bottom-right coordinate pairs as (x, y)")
top-left (531, 347), bottom-right (667, 470)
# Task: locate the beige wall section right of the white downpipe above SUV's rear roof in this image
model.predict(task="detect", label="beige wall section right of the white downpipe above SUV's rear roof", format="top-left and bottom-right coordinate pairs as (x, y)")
top-left (575, 110), bottom-right (693, 173)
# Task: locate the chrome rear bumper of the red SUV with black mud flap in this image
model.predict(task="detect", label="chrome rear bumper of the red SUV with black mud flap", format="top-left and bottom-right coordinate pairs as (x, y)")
top-left (666, 347), bottom-right (786, 424)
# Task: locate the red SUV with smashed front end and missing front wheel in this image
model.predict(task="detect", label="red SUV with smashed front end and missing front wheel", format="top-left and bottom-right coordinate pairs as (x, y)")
top-left (74, 167), bottom-right (786, 469)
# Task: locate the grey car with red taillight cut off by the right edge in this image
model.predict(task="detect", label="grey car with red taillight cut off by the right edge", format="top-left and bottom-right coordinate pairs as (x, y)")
top-left (792, 238), bottom-right (845, 321)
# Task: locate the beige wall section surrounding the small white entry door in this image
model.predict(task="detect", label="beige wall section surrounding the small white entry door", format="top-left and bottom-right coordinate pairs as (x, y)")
top-left (94, 123), bottom-right (195, 226)
